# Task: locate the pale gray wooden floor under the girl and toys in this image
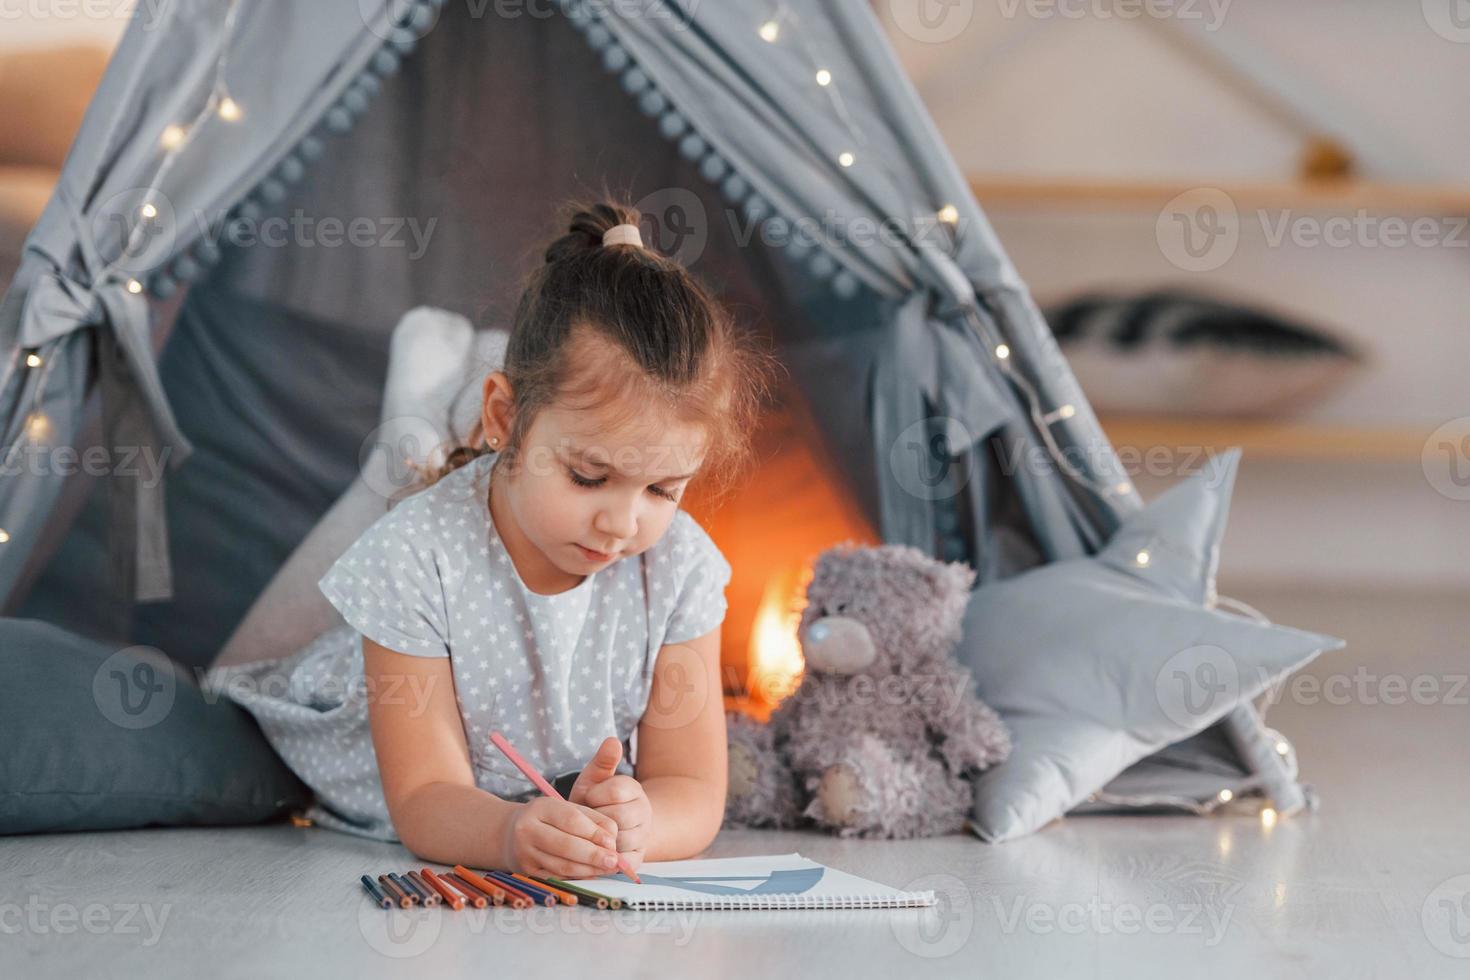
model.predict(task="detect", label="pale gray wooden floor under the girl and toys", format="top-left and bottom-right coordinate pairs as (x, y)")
top-left (0, 592), bottom-right (1470, 980)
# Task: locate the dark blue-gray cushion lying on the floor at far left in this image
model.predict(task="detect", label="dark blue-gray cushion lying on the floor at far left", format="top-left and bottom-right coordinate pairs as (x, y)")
top-left (0, 619), bottom-right (310, 833)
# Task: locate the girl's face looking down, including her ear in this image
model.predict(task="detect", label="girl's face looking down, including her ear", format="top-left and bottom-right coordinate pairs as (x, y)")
top-left (482, 372), bottom-right (704, 594)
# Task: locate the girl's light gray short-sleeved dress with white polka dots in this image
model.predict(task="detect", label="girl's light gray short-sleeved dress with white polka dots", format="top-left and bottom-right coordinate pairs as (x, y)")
top-left (209, 453), bottom-right (731, 840)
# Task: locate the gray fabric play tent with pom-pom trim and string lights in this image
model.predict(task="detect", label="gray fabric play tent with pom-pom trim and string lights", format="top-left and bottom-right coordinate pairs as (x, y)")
top-left (0, 0), bottom-right (1299, 828)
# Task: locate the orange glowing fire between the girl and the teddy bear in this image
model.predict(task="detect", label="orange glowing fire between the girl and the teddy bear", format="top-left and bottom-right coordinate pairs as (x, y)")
top-left (688, 393), bottom-right (878, 720)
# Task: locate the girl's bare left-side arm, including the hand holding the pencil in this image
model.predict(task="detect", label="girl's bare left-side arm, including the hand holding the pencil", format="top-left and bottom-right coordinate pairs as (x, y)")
top-left (363, 636), bottom-right (617, 877)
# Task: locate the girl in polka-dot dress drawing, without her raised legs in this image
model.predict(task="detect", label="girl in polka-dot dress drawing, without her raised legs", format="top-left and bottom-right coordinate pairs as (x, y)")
top-left (216, 203), bottom-right (769, 877)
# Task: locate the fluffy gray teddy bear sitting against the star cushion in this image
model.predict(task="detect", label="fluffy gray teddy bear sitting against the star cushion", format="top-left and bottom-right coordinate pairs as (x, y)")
top-left (725, 544), bottom-right (1010, 837)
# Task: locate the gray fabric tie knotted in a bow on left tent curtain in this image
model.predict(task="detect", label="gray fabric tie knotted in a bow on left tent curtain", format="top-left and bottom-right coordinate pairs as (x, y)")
top-left (21, 273), bottom-right (194, 602)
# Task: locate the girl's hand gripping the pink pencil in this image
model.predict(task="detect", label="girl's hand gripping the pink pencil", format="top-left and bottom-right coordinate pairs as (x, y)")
top-left (504, 796), bottom-right (619, 879)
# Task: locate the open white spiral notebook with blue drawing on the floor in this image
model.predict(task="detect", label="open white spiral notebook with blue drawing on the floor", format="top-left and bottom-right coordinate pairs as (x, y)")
top-left (585, 852), bottom-right (935, 909)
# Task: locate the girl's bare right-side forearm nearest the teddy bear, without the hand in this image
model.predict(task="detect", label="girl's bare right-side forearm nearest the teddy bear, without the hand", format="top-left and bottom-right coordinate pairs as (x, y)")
top-left (637, 627), bottom-right (729, 861)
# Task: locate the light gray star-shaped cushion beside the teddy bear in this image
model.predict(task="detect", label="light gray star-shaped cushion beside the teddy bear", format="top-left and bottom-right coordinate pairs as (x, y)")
top-left (957, 451), bottom-right (1342, 840)
